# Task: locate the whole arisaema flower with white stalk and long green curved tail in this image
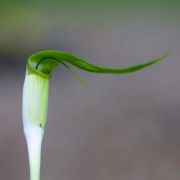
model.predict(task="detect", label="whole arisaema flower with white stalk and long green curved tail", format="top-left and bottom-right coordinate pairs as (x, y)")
top-left (23, 50), bottom-right (168, 180)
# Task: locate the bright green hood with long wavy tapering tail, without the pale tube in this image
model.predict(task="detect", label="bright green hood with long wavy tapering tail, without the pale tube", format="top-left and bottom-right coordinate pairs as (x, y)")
top-left (28, 50), bottom-right (169, 76)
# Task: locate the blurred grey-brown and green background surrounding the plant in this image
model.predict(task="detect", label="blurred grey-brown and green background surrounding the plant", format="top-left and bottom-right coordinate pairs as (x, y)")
top-left (0, 0), bottom-right (180, 180)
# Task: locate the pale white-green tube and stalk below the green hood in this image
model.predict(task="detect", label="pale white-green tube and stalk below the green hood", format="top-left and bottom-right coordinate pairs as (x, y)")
top-left (23, 69), bottom-right (49, 180)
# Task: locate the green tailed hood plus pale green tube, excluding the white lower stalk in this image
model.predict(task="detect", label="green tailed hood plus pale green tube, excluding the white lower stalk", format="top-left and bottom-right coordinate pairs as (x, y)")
top-left (23, 50), bottom-right (168, 129)
